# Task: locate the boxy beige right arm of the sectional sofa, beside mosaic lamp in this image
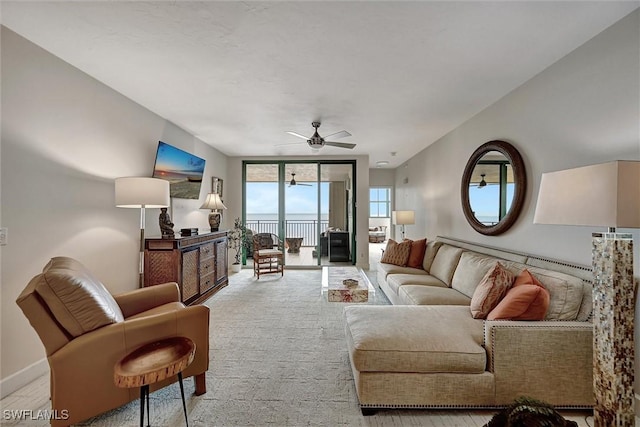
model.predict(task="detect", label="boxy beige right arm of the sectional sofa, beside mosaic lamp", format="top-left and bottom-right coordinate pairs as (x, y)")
top-left (484, 320), bottom-right (594, 407)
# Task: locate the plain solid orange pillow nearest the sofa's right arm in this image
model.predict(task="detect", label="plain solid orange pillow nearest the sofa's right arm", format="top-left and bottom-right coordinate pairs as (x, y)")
top-left (487, 269), bottom-right (550, 320)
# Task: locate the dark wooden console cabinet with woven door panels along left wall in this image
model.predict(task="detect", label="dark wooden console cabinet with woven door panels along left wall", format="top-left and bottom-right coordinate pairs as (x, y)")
top-left (144, 231), bottom-right (229, 305)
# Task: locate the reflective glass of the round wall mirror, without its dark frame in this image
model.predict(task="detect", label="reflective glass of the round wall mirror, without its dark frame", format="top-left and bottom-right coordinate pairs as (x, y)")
top-left (469, 151), bottom-right (515, 226)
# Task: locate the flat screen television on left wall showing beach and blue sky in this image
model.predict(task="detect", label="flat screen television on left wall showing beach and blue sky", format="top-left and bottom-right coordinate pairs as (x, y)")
top-left (153, 141), bottom-right (205, 199)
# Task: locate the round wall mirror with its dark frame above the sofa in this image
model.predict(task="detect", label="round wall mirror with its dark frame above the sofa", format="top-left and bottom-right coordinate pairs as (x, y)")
top-left (460, 140), bottom-right (527, 236)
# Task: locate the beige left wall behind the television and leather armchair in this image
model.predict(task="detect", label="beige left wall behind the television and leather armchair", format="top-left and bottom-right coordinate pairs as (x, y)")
top-left (0, 27), bottom-right (227, 395)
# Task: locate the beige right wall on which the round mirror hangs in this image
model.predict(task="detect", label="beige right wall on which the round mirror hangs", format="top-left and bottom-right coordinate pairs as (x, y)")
top-left (395, 7), bottom-right (640, 398)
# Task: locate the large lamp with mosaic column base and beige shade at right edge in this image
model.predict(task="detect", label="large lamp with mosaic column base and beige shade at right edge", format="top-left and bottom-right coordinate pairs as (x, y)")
top-left (534, 161), bottom-right (640, 427)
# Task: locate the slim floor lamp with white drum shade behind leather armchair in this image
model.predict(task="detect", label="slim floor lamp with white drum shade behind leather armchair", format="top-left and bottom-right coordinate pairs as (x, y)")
top-left (116, 177), bottom-right (169, 287)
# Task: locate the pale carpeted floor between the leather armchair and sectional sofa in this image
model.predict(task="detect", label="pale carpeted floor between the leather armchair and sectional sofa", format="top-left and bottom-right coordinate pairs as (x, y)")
top-left (1, 269), bottom-right (593, 427)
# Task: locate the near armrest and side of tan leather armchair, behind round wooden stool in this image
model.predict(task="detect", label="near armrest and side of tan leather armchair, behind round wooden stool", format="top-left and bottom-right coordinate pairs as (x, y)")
top-left (49, 306), bottom-right (209, 425)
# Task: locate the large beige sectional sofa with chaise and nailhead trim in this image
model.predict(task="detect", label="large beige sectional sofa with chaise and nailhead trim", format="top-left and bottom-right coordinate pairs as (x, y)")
top-left (344, 237), bottom-right (594, 413)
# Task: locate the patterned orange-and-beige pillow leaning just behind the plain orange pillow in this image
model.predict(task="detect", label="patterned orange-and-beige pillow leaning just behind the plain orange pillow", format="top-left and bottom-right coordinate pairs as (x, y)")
top-left (471, 262), bottom-right (514, 319)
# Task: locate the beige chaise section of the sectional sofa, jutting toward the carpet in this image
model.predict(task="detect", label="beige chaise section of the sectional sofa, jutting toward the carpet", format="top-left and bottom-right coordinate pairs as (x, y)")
top-left (343, 306), bottom-right (495, 414)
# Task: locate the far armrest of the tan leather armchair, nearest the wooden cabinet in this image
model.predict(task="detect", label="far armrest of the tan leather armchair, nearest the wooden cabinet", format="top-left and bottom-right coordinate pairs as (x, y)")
top-left (113, 282), bottom-right (180, 319)
